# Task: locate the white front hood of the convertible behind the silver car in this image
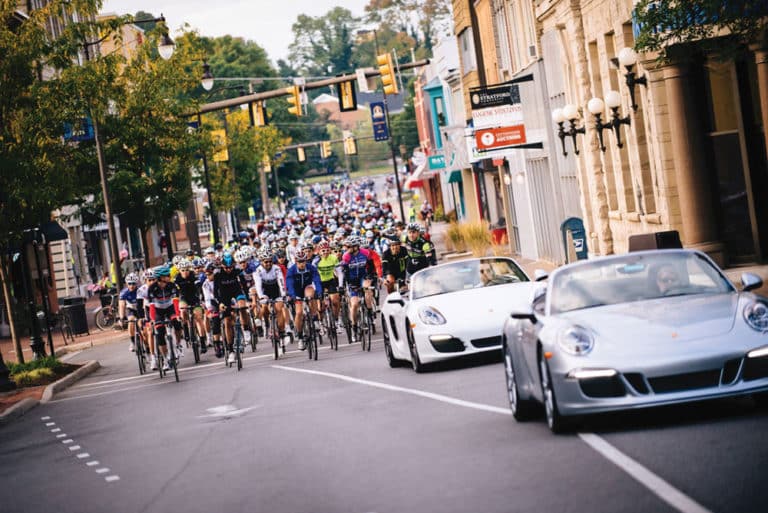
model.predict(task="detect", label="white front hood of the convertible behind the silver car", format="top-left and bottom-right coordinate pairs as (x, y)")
top-left (409, 282), bottom-right (534, 328)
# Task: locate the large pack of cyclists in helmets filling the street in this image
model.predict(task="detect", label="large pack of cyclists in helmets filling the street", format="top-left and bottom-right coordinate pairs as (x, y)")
top-left (118, 181), bottom-right (437, 370)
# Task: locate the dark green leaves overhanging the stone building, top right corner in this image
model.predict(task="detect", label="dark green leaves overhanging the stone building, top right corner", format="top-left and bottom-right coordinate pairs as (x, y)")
top-left (634, 0), bottom-right (768, 59)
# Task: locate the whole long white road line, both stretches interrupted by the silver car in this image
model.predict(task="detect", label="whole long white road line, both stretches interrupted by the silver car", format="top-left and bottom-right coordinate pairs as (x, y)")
top-left (272, 365), bottom-right (711, 513)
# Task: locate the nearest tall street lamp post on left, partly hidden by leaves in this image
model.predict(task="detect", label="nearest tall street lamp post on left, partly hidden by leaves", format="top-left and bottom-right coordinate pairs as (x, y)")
top-left (83, 14), bottom-right (174, 290)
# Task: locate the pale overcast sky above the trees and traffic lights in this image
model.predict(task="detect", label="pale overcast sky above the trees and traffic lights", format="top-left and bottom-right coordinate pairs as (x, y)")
top-left (102, 0), bottom-right (368, 63)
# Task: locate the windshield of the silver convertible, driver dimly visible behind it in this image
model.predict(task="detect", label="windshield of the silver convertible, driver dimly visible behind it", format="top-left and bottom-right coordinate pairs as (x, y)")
top-left (550, 251), bottom-right (734, 314)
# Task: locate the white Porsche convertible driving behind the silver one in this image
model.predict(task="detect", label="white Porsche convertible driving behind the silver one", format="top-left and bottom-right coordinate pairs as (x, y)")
top-left (381, 257), bottom-right (534, 372)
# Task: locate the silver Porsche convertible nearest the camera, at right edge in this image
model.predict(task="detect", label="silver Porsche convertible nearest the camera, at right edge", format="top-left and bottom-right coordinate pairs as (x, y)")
top-left (502, 250), bottom-right (768, 433)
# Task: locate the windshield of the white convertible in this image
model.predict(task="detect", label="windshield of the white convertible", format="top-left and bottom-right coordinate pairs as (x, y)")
top-left (411, 258), bottom-right (528, 299)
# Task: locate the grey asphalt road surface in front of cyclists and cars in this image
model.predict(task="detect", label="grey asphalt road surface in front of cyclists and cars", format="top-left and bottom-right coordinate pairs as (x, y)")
top-left (0, 326), bottom-right (768, 513)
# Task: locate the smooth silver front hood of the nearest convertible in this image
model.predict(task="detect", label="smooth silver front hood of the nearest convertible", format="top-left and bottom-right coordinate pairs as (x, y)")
top-left (561, 294), bottom-right (739, 341)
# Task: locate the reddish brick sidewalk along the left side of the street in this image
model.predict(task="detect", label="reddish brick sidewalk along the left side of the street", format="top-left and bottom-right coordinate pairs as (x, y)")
top-left (0, 296), bottom-right (128, 363)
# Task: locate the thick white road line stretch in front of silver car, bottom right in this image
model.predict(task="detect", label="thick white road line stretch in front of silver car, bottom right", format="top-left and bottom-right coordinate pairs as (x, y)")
top-left (579, 433), bottom-right (711, 513)
